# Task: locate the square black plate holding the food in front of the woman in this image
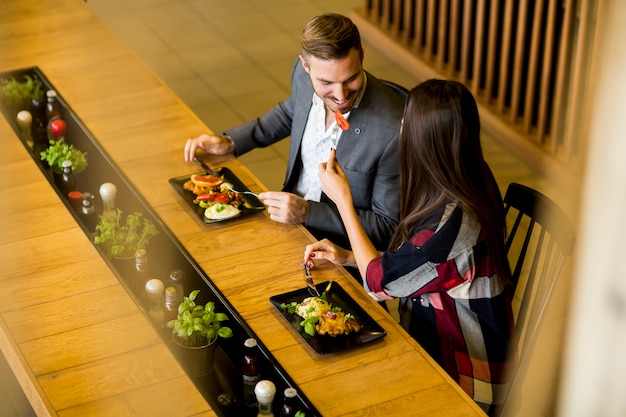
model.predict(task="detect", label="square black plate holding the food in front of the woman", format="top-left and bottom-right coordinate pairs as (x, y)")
top-left (270, 281), bottom-right (387, 355)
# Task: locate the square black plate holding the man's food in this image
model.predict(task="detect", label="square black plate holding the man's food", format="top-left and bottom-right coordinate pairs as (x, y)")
top-left (169, 167), bottom-right (265, 224)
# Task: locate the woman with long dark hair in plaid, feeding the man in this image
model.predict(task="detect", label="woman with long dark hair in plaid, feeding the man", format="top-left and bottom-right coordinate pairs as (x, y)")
top-left (304, 80), bottom-right (513, 411)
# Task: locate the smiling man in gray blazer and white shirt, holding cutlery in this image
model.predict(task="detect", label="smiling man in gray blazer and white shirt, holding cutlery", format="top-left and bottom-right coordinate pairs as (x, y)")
top-left (185, 14), bottom-right (404, 250)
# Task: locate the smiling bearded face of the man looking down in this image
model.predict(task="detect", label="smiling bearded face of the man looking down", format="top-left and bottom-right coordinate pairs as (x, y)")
top-left (300, 49), bottom-right (364, 113)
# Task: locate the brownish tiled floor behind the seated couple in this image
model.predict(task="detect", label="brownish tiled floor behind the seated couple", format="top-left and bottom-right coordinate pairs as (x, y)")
top-left (81, 0), bottom-right (556, 205)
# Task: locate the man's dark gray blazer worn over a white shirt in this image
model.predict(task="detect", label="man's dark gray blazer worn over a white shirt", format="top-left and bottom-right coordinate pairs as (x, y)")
top-left (225, 59), bottom-right (404, 250)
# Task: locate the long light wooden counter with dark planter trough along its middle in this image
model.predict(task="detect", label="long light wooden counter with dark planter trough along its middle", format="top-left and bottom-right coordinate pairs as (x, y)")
top-left (0, 0), bottom-right (483, 417)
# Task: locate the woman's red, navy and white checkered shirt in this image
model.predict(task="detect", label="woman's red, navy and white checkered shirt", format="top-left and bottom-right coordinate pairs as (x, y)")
top-left (365, 204), bottom-right (515, 411)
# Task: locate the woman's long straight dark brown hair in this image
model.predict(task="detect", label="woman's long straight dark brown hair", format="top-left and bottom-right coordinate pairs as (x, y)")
top-left (389, 80), bottom-right (510, 282)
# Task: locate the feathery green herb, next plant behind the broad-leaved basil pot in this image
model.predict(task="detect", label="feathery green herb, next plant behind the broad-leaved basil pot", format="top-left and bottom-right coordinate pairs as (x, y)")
top-left (94, 209), bottom-right (160, 259)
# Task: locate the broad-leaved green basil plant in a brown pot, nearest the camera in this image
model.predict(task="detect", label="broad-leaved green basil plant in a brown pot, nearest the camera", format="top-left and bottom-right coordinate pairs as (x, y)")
top-left (167, 290), bottom-right (233, 377)
